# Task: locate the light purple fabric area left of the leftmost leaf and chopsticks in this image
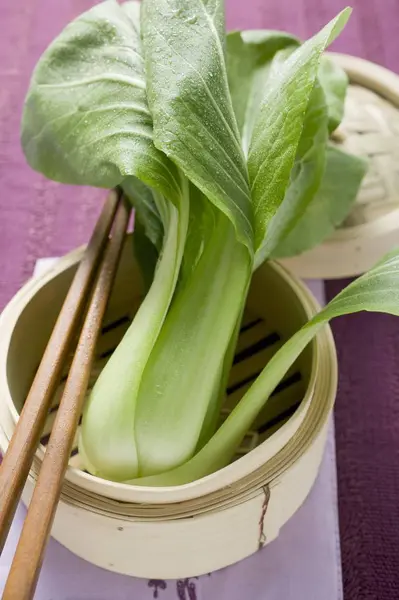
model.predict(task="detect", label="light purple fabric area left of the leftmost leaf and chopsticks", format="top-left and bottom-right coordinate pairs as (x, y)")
top-left (0, 0), bottom-right (102, 316)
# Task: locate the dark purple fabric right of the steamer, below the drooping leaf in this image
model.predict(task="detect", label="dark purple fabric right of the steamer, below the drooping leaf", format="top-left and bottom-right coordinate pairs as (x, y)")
top-left (326, 282), bottom-right (399, 600)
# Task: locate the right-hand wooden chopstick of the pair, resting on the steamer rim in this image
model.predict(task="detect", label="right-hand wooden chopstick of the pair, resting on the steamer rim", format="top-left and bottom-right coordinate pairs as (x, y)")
top-left (3, 201), bottom-right (130, 600)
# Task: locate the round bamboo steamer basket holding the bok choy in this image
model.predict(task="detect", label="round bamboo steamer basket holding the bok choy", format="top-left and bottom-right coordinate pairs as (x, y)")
top-left (0, 236), bottom-right (337, 579)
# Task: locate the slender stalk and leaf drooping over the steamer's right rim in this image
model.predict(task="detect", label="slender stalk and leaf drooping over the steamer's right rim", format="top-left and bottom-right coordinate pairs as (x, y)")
top-left (130, 249), bottom-right (399, 486)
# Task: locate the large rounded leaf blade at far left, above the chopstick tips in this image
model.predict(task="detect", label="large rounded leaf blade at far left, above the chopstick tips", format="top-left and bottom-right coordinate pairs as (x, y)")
top-left (22, 0), bottom-right (180, 199)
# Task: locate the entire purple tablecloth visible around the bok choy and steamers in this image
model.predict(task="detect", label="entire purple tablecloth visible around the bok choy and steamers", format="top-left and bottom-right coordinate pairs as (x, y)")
top-left (0, 0), bottom-right (399, 600)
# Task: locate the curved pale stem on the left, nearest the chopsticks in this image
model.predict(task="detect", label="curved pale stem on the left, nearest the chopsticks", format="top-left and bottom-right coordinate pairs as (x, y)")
top-left (79, 180), bottom-right (189, 480)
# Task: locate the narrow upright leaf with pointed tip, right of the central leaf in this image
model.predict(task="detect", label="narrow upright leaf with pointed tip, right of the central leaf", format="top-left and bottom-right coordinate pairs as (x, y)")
top-left (248, 9), bottom-right (350, 250)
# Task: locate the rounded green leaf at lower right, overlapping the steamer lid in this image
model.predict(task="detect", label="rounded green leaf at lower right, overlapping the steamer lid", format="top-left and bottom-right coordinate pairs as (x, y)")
top-left (272, 146), bottom-right (367, 258)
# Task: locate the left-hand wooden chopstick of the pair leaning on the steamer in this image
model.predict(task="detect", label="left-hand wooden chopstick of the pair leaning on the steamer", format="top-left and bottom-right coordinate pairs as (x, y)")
top-left (0, 191), bottom-right (120, 553)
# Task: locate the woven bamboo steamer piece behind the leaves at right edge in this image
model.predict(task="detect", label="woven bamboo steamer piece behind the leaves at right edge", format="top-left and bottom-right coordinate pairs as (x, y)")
top-left (281, 53), bottom-right (399, 279)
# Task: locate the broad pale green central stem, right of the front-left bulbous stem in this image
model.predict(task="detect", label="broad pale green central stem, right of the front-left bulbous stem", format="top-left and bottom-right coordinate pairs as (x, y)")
top-left (135, 213), bottom-right (252, 475)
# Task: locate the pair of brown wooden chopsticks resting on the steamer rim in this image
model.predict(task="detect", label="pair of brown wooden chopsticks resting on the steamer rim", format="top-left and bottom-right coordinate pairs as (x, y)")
top-left (0, 190), bottom-right (130, 600)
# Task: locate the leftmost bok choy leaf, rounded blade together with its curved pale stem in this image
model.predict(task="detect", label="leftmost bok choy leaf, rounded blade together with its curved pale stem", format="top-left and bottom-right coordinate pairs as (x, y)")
top-left (22, 0), bottom-right (189, 477)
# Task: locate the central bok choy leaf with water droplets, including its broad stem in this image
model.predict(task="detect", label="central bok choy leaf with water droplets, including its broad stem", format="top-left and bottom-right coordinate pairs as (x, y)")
top-left (134, 0), bottom-right (253, 474)
